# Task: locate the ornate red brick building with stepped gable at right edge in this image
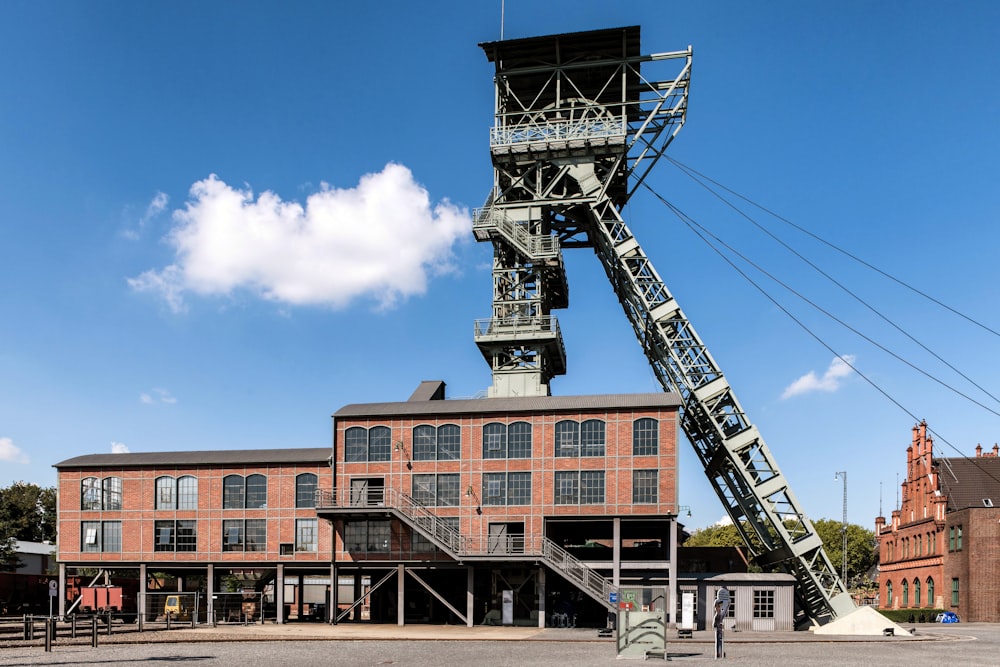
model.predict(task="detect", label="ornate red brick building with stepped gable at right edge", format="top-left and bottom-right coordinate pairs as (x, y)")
top-left (875, 422), bottom-right (1000, 622)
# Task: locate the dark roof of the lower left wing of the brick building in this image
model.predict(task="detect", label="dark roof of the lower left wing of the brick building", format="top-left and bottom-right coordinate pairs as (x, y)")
top-left (53, 447), bottom-right (333, 468)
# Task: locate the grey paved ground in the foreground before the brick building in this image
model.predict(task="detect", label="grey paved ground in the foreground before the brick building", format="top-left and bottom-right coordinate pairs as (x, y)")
top-left (0, 624), bottom-right (1000, 667)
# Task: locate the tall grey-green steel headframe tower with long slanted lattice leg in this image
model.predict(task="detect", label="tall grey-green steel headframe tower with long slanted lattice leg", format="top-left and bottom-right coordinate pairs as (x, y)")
top-left (473, 27), bottom-right (854, 623)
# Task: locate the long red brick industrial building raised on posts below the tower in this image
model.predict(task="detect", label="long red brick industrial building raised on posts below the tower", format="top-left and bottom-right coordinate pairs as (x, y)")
top-left (55, 382), bottom-right (679, 626)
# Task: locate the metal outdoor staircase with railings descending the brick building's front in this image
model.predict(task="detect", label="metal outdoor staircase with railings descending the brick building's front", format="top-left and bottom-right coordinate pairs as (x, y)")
top-left (316, 488), bottom-right (615, 609)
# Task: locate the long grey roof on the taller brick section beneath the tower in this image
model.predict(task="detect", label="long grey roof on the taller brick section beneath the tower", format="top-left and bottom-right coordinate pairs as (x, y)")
top-left (333, 392), bottom-right (681, 419)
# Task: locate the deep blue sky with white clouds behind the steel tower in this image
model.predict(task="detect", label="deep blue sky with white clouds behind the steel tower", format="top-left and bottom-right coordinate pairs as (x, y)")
top-left (0, 0), bottom-right (1000, 528)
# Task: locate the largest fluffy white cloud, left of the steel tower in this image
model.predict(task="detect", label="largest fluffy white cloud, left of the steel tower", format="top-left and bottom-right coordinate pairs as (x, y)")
top-left (128, 163), bottom-right (470, 311)
